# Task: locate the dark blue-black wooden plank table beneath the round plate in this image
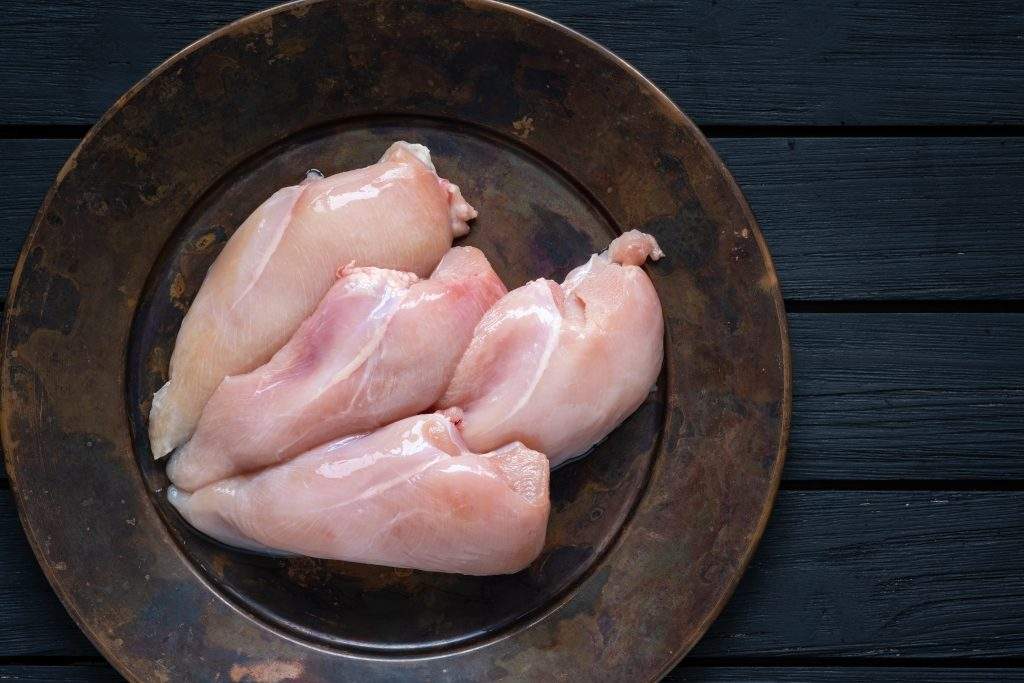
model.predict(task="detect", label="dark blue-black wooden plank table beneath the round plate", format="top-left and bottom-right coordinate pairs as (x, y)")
top-left (0, 0), bottom-right (1024, 682)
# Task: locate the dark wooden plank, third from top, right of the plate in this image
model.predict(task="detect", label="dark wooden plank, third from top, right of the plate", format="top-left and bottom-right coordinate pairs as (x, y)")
top-left (783, 313), bottom-right (1024, 480)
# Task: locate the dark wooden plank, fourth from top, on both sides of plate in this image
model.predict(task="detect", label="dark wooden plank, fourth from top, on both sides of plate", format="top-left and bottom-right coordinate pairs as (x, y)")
top-left (0, 490), bottom-right (1024, 664)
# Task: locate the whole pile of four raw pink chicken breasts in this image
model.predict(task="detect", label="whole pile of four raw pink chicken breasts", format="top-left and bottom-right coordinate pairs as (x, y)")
top-left (150, 142), bottom-right (664, 574)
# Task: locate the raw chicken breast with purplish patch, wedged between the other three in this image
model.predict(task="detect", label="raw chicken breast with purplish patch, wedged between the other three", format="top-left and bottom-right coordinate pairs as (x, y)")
top-left (167, 247), bottom-right (506, 490)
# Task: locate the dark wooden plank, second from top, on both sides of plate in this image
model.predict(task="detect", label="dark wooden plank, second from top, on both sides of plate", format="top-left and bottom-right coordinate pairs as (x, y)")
top-left (0, 138), bottom-right (1024, 301)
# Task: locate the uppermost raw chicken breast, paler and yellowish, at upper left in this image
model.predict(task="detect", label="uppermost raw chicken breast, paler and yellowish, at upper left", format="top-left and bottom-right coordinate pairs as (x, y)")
top-left (150, 142), bottom-right (476, 458)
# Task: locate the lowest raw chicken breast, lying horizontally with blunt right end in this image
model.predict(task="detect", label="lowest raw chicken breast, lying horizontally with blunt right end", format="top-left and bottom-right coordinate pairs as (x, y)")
top-left (168, 414), bottom-right (550, 574)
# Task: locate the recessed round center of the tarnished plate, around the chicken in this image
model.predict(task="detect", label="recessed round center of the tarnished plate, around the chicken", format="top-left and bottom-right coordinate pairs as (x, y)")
top-left (128, 117), bottom-right (664, 652)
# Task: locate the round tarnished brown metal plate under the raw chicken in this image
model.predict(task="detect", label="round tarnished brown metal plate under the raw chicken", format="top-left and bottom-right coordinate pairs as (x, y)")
top-left (2, 0), bottom-right (790, 681)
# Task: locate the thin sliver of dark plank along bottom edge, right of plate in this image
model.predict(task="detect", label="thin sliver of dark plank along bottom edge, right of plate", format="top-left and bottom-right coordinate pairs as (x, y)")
top-left (663, 663), bottom-right (1024, 683)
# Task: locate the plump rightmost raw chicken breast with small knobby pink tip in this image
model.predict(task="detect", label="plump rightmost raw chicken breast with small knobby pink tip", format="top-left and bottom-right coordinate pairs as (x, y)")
top-left (438, 230), bottom-right (664, 467)
